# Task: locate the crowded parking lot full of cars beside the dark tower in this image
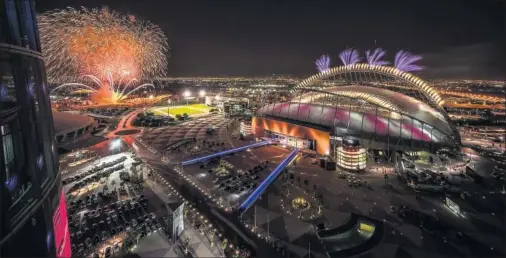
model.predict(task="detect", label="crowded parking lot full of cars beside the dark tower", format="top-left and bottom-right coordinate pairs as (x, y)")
top-left (62, 153), bottom-right (173, 257)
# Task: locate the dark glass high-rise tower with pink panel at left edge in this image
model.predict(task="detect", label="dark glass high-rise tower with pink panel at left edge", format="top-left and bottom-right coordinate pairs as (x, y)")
top-left (0, 0), bottom-right (71, 257)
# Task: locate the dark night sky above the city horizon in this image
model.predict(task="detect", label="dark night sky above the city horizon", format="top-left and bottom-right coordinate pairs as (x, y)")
top-left (36, 0), bottom-right (506, 80)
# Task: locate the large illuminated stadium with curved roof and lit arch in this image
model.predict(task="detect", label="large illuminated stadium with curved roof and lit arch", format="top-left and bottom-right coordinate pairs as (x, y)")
top-left (252, 63), bottom-right (460, 170)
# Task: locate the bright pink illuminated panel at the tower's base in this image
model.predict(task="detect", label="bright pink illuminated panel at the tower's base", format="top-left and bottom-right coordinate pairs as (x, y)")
top-left (53, 191), bottom-right (72, 258)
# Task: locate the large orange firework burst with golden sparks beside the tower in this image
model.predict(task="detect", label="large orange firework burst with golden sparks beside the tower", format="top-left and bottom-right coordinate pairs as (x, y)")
top-left (38, 8), bottom-right (169, 103)
